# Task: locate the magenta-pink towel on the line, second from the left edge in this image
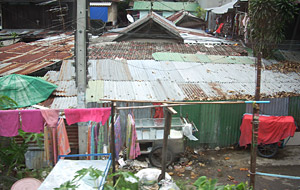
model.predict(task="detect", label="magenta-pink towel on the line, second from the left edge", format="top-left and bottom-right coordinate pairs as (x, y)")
top-left (20, 110), bottom-right (44, 133)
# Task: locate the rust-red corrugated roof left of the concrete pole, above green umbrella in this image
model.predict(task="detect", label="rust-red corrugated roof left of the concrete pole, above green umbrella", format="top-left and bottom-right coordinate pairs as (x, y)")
top-left (0, 35), bottom-right (74, 76)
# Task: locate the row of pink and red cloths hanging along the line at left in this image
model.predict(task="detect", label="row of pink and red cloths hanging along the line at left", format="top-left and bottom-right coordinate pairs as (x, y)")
top-left (0, 108), bottom-right (111, 137)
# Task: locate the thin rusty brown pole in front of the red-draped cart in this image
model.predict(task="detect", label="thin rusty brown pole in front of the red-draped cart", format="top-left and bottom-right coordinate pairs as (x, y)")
top-left (250, 52), bottom-right (261, 189)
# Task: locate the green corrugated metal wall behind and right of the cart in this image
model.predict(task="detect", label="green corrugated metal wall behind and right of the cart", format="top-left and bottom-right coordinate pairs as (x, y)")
top-left (175, 104), bottom-right (246, 148)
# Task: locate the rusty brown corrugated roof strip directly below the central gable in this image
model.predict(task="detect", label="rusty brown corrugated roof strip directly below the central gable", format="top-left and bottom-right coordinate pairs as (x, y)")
top-left (89, 42), bottom-right (248, 60)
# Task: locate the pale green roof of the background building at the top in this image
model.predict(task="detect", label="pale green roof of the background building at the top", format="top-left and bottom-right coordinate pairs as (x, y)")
top-left (133, 1), bottom-right (199, 12)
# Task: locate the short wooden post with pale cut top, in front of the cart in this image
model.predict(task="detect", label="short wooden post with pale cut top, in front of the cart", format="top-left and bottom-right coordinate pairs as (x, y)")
top-left (158, 107), bottom-right (177, 181)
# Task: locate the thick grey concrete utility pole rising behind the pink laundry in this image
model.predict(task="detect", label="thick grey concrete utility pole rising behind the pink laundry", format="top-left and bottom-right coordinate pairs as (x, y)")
top-left (75, 0), bottom-right (87, 154)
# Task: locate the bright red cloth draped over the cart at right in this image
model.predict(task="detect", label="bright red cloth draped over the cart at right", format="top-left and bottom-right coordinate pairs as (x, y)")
top-left (240, 114), bottom-right (296, 146)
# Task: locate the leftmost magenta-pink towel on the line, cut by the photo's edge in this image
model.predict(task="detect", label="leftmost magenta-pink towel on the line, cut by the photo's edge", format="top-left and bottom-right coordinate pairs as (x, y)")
top-left (0, 110), bottom-right (20, 137)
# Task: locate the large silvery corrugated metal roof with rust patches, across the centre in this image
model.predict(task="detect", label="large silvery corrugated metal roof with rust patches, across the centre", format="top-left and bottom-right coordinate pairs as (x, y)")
top-left (56, 60), bottom-right (300, 102)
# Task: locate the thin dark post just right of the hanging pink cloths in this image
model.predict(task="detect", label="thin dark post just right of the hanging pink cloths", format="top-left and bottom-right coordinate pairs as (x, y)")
top-left (110, 102), bottom-right (116, 185)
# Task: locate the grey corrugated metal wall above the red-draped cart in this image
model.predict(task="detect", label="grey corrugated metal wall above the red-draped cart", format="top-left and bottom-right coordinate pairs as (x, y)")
top-left (246, 98), bottom-right (289, 116)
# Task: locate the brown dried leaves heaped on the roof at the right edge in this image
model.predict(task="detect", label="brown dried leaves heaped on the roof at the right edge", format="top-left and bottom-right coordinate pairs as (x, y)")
top-left (266, 61), bottom-right (300, 73)
